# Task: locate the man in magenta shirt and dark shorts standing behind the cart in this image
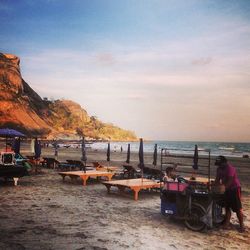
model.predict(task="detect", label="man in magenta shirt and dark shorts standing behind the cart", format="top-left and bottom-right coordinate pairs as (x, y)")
top-left (215, 155), bottom-right (245, 232)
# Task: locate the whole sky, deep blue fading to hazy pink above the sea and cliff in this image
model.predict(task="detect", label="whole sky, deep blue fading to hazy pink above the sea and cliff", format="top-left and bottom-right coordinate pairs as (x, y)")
top-left (0, 0), bottom-right (250, 142)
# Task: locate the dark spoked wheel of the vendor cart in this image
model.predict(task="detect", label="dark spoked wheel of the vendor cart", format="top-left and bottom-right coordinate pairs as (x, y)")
top-left (185, 203), bottom-right (206, 231)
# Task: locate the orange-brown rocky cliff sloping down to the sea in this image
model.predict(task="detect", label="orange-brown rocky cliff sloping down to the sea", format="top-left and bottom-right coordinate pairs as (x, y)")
top-left (0, 53), bottom-right (136, 140)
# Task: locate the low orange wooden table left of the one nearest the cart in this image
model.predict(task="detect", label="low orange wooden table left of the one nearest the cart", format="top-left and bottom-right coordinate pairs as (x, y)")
top-left (58, 170), bottom-right (114, 186)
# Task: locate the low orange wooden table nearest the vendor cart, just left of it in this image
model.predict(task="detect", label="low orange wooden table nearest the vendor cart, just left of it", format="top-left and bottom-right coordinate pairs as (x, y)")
top-left (102, 178), bottom-right (160, 201)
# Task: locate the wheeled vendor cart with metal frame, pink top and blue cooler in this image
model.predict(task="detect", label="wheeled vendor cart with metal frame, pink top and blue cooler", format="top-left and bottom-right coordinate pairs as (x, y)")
top-left (161, 147), bottom-right (224, 231)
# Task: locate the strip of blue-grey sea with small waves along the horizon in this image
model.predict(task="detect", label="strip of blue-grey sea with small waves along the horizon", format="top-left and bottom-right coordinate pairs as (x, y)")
top-left (91, 141), bottom-right (250, 157)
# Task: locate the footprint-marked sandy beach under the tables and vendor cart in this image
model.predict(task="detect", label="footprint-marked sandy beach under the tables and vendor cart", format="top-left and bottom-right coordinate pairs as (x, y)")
top-left (0, 148), bottom-right (250, 250)
